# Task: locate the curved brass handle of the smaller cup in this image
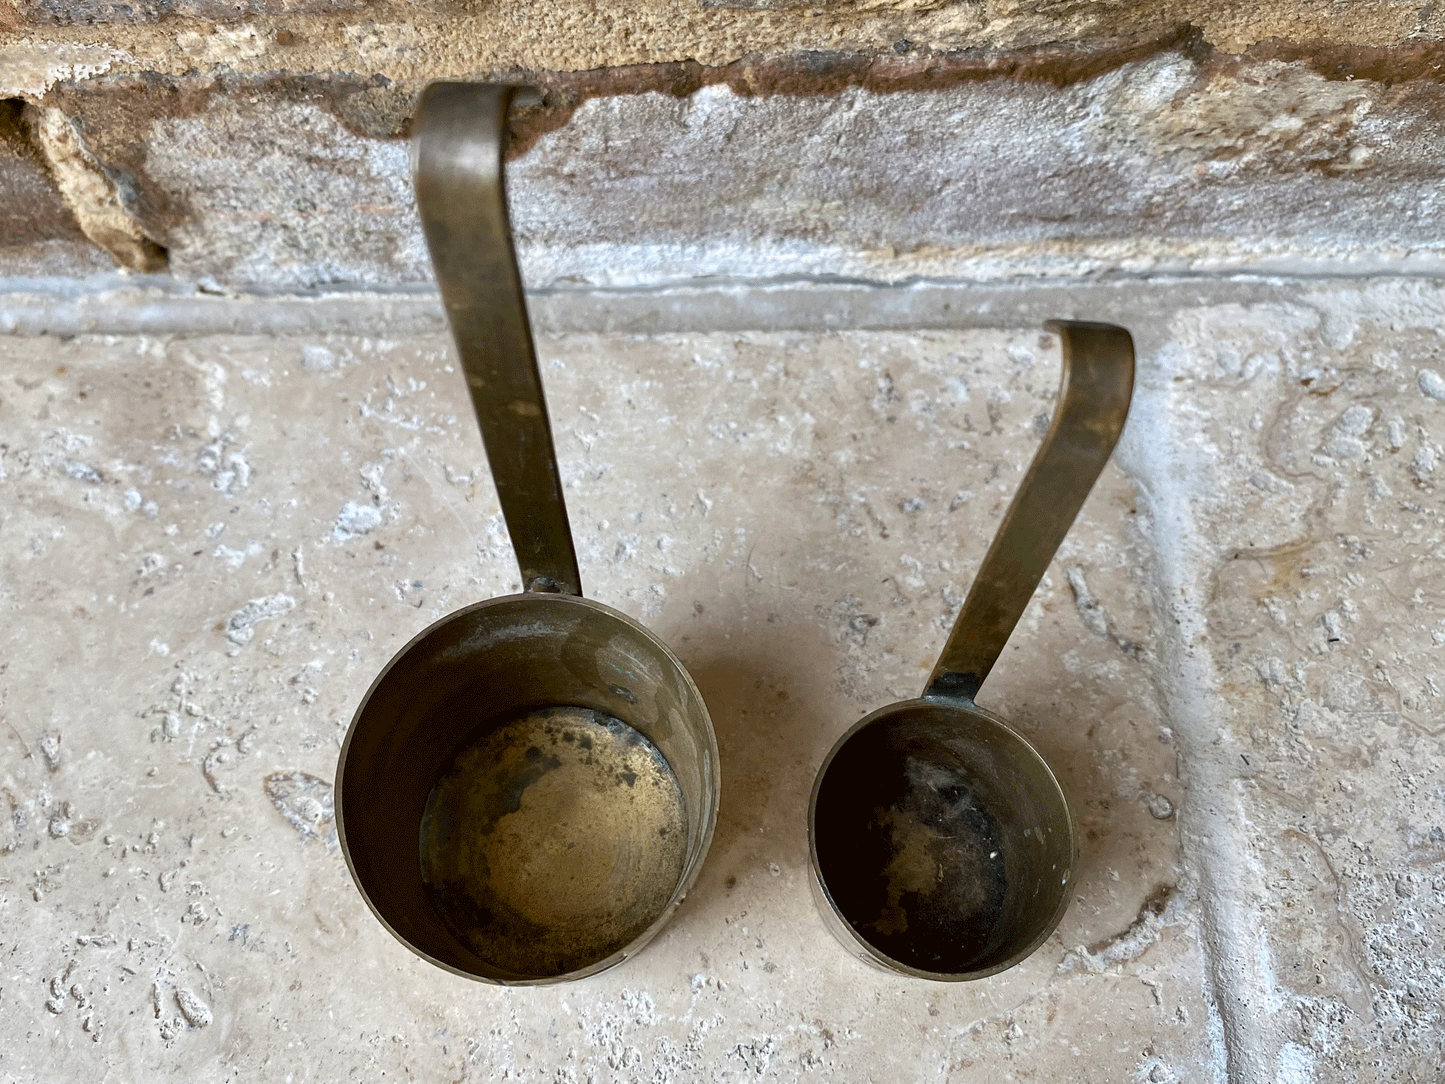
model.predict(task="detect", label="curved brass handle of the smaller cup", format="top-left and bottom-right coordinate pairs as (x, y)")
top-left (923, 321), bottom-right (1134, 702)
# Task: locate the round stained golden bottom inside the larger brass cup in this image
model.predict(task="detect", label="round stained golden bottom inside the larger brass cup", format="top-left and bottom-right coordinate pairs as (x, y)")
top-left (420, 707), bottom-right (688, 978)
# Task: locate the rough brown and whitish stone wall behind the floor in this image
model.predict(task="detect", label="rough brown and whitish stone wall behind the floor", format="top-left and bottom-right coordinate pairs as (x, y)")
top-left (0, 0), bottom-right (1445, 289)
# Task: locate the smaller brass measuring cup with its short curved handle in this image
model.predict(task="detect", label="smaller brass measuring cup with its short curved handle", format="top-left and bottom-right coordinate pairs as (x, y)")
top-left (808, 321), bottom-right (1134, 981)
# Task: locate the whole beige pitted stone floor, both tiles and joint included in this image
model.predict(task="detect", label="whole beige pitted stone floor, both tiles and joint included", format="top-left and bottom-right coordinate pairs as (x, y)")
top-left (0, 279), bottom-right (1445, 1084)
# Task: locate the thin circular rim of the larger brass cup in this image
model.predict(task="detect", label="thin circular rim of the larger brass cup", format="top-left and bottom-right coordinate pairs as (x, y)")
top-left (332, 591), bottom-right (723, 986)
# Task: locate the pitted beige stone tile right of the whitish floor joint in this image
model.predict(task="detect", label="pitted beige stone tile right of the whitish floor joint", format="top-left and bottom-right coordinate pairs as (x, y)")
top-left (1169, 283), bottom-right (1445, 1081)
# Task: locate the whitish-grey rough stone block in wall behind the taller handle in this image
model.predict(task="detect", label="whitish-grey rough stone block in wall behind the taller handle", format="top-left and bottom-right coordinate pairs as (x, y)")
top-left (28, 53), bottom-right (1445, 289)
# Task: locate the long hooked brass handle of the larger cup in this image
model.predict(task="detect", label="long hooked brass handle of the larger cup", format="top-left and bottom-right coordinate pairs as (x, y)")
top-left (415, 82), bottom-right (582, 595)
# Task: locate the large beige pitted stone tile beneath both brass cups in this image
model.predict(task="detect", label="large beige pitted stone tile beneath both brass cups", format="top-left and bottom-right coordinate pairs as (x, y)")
top-left (0, 331), bottom-right (1215, 1083)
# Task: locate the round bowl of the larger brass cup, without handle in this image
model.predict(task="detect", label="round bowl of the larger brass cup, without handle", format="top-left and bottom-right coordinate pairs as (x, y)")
top-left (337, 594), bottom-right (718, 984)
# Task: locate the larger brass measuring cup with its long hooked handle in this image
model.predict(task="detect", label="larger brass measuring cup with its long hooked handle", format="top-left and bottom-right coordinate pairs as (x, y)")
top-left (335, 84), bottom-right (720, 984)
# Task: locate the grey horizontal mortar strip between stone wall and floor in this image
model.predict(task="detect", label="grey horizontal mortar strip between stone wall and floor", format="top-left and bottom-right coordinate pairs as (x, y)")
top-left (8, 270), bottom-right (1445, 335)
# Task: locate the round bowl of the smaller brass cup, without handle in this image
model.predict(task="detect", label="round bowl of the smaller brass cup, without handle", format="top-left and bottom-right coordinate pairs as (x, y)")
top-left (808, 700), bottom-right (1078, 980)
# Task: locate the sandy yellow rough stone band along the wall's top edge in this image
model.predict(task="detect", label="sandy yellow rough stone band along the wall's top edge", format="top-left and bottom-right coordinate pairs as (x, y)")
top-left (0, 0), bottom-right (1445, 78)
